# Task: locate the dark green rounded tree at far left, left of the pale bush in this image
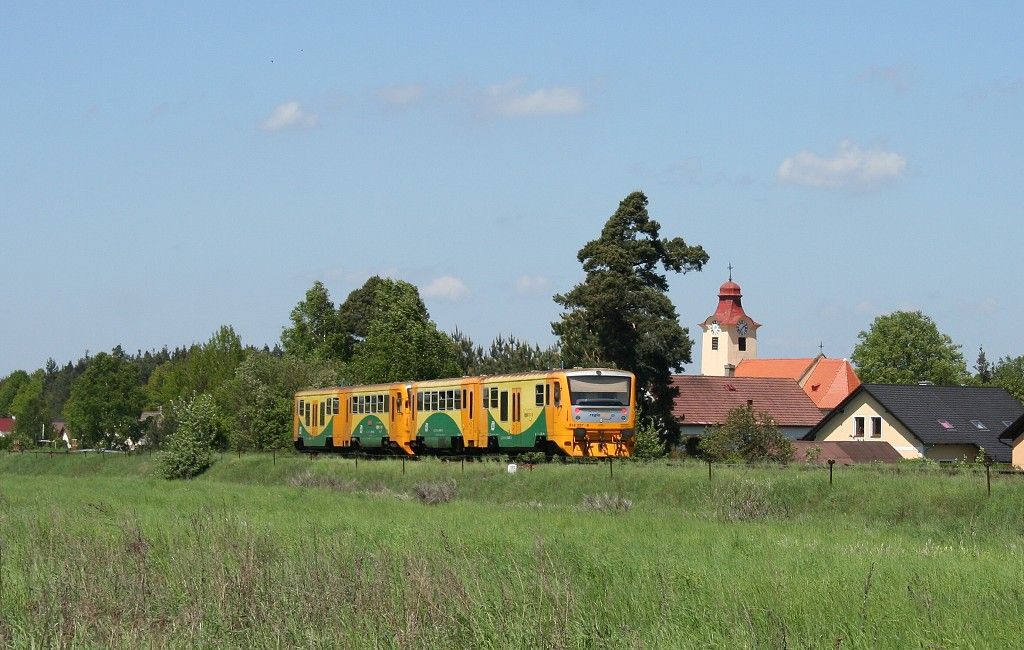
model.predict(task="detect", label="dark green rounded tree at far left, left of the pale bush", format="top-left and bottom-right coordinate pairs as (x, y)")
top-left (65, 352), bottom-right (145, 447)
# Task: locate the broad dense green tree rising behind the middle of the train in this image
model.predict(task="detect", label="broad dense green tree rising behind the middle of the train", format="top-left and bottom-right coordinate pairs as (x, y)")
top-left (349, 279), bottom-right (460, 384)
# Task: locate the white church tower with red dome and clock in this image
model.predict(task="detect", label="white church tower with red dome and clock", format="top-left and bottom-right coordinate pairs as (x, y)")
top-left (700, 274), bottom-right (761, 377)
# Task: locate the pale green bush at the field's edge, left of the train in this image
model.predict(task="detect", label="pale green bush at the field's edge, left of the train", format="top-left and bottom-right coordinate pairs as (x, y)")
top-left (158, 393), bottom-right (223, 479)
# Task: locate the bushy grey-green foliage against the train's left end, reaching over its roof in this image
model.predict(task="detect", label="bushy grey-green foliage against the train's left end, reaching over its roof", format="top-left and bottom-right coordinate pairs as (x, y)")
top-left (217, 351), bottom-right (341, 450)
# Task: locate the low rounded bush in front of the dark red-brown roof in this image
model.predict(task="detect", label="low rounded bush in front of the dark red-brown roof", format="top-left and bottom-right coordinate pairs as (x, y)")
top-left (700, 406), bottom-right (794, 463)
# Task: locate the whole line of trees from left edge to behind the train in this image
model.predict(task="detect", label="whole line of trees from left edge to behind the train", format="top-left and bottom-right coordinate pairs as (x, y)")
top-left (0, 276), bottom-right (561, 450)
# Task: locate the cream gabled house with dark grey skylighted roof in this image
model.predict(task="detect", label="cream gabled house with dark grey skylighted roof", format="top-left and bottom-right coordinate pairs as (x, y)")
top-left (804, 384), bottom-right (1024, 463)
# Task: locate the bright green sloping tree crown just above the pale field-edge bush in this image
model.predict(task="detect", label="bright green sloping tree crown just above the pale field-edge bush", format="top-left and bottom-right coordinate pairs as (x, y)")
top-left (145, 326), bottom-right (245, 407)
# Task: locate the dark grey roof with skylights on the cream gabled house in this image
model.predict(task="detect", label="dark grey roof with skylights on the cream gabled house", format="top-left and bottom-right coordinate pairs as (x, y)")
top-left (805, 384), bottom-right (1024, 463)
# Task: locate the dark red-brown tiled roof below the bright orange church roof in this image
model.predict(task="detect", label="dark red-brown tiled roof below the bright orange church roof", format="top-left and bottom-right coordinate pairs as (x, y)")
top-left (672, 375), bottom-right (821, 427)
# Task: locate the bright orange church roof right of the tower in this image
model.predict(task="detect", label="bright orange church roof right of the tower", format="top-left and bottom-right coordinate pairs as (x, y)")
top-left (736, 354), bottom-right (860, 414)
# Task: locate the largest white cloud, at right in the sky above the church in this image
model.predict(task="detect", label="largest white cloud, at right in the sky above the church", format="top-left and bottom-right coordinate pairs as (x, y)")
top-left (778, 140), bottom-right (906, 187)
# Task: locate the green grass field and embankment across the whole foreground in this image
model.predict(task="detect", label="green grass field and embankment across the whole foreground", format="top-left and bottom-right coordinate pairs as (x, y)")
top-left (0, 454), bottom-right (1024, 648)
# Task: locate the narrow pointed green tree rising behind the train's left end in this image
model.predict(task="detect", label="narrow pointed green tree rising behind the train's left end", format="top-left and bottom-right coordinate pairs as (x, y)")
top-left (281, 280), bottom-right (346, 359)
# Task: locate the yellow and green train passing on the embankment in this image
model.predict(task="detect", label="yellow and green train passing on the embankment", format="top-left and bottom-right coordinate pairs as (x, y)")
top-left (292, 369), bottom-right (636, 458)
